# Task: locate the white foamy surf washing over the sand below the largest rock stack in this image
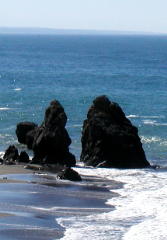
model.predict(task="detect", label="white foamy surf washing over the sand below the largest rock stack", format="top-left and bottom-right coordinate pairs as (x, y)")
top-left (58, 168), bottom-right (167, 240)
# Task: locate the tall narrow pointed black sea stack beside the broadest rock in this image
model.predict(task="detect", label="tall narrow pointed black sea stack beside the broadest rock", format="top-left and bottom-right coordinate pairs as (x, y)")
top-left (32, 100), bottom-right (76, 167)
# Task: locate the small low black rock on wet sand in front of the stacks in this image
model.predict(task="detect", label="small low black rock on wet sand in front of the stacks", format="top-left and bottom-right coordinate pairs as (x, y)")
top-left (57, 168), bottom-right (82, 181)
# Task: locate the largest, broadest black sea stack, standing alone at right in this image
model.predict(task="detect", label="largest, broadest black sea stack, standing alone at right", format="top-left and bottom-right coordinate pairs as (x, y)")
top-left (81, 96), bottom-right (150, 168)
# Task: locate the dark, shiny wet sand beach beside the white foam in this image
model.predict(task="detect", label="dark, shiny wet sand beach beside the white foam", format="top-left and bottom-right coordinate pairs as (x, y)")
top-left (0, 165), bottom-right (120, 240)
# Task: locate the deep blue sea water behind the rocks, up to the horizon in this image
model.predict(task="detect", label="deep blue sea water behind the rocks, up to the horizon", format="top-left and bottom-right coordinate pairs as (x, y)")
top-left (0, 35), bottom-right (167, 165)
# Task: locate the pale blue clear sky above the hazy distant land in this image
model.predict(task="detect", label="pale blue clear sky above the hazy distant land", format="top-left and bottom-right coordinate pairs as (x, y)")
top-left (0, 0), bottom-right (167, 33)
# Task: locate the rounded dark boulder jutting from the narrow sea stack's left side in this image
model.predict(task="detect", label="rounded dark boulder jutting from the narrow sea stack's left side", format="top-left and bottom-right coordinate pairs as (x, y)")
top-left (16, 122), bottom-right (37, 144)
